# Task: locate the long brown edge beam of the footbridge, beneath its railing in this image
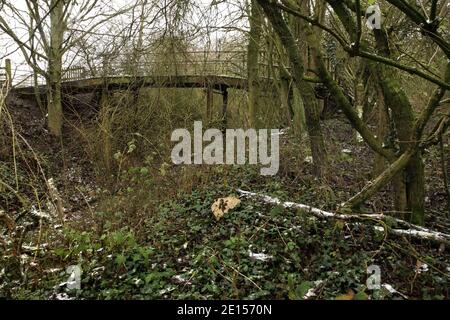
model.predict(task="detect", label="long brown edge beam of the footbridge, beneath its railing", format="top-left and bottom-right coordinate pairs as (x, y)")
top-left (13, 75), bottom-right (251, 95)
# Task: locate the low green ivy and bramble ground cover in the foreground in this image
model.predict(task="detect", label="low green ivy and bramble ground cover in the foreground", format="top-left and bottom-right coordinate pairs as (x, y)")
top-left (3, 168), bottom-right (449, 299)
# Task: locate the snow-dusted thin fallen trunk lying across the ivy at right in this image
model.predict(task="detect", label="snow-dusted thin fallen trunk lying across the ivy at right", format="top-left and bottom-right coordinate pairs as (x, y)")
top-left (237, 189), bottom-right (450, 244)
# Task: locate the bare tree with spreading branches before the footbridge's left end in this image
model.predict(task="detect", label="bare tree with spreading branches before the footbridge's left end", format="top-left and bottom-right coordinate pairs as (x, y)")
top-left (0, 0), bottom-right (130, 136)
